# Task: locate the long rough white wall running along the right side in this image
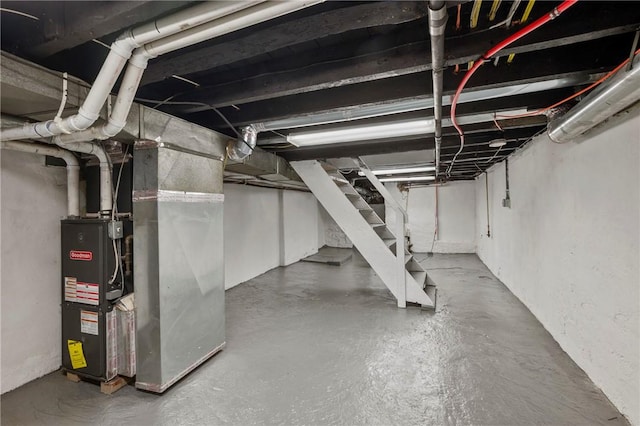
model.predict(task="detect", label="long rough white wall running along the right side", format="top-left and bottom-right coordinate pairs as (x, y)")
top-left (476, 108), bottom-right (640, 425)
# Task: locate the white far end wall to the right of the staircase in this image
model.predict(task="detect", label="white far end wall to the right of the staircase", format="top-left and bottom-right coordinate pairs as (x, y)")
top-left (385, 181), bottom-right (476, 253)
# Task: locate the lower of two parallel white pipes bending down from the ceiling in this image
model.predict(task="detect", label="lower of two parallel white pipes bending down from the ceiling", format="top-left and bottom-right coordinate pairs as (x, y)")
top-left (54, 0), bottom-right (320, 145)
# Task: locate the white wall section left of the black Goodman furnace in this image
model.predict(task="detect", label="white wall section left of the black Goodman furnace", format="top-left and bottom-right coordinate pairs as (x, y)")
top-left (0, 150), bottom-right (67, 393)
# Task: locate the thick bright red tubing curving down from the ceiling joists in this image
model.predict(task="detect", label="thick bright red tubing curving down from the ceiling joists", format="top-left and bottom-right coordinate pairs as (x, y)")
top-left (449, 0), bottom-right (578, 170)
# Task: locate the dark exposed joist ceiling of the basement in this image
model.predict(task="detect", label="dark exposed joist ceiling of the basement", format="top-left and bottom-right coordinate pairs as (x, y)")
top-left (0, 0), bottom-right (640, 180)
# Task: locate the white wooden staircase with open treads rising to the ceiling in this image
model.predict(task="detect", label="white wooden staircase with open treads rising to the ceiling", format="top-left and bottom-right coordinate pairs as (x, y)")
top-left (291, 160), bottom-right (436, 309)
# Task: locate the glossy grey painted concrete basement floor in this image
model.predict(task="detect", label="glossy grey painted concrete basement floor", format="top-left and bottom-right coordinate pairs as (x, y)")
top-left (1, 255), bottom-right (627, 425)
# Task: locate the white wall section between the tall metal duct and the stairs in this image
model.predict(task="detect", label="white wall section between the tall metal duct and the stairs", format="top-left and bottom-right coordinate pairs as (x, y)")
top-left (224, 184), bottom-right (322, 289)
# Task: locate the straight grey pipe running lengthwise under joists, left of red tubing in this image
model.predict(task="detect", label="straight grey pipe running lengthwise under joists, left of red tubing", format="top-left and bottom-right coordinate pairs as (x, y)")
top-left (429, 1), bottom-right (447, 176)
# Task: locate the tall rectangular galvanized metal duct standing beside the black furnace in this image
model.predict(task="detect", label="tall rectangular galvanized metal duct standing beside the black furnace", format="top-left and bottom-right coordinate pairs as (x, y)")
top-left (133, 116), bottom-right (227, 392)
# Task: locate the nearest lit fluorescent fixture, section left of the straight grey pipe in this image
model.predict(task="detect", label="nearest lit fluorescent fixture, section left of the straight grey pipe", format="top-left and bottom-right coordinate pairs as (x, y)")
top-left (287, 119), bottom-right (435, 146)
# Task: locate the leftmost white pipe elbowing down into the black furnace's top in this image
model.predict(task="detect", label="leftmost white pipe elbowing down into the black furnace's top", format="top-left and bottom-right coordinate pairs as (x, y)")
top-left (2, 141), bottom-right (80, 217)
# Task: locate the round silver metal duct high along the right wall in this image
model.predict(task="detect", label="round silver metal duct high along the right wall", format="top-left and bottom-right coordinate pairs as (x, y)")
top-left (548, 55), bottom-right (640, 143)
